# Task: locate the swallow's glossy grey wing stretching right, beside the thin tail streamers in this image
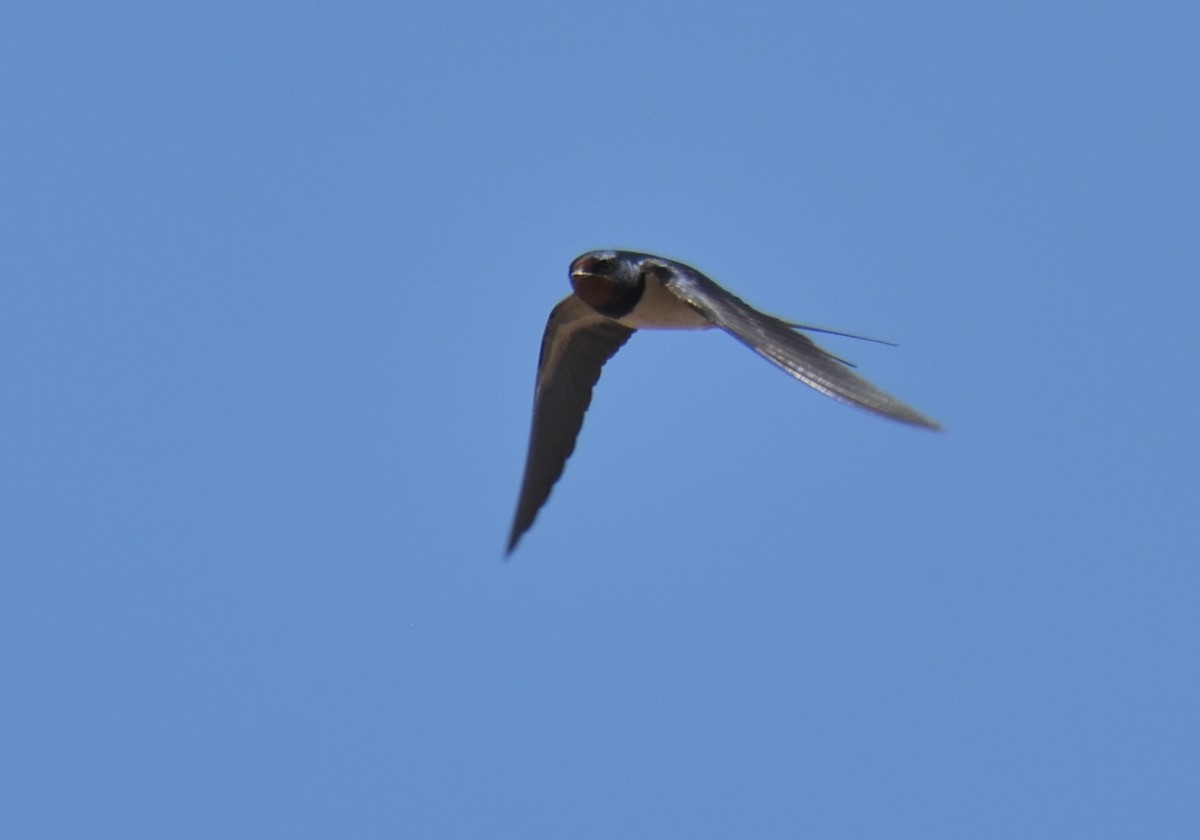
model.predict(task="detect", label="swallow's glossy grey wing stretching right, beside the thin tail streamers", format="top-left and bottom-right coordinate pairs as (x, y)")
top-left (664, 268), bottom-right (941, 430)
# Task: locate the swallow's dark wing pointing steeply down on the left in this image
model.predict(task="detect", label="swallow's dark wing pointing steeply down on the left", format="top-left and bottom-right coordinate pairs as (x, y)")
top-left (508, 295), bottom-right (634, 553)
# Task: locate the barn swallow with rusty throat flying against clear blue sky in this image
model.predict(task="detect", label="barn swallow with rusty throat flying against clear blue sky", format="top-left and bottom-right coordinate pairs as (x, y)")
top-left (505, 251), bottom-right (941, 554)
